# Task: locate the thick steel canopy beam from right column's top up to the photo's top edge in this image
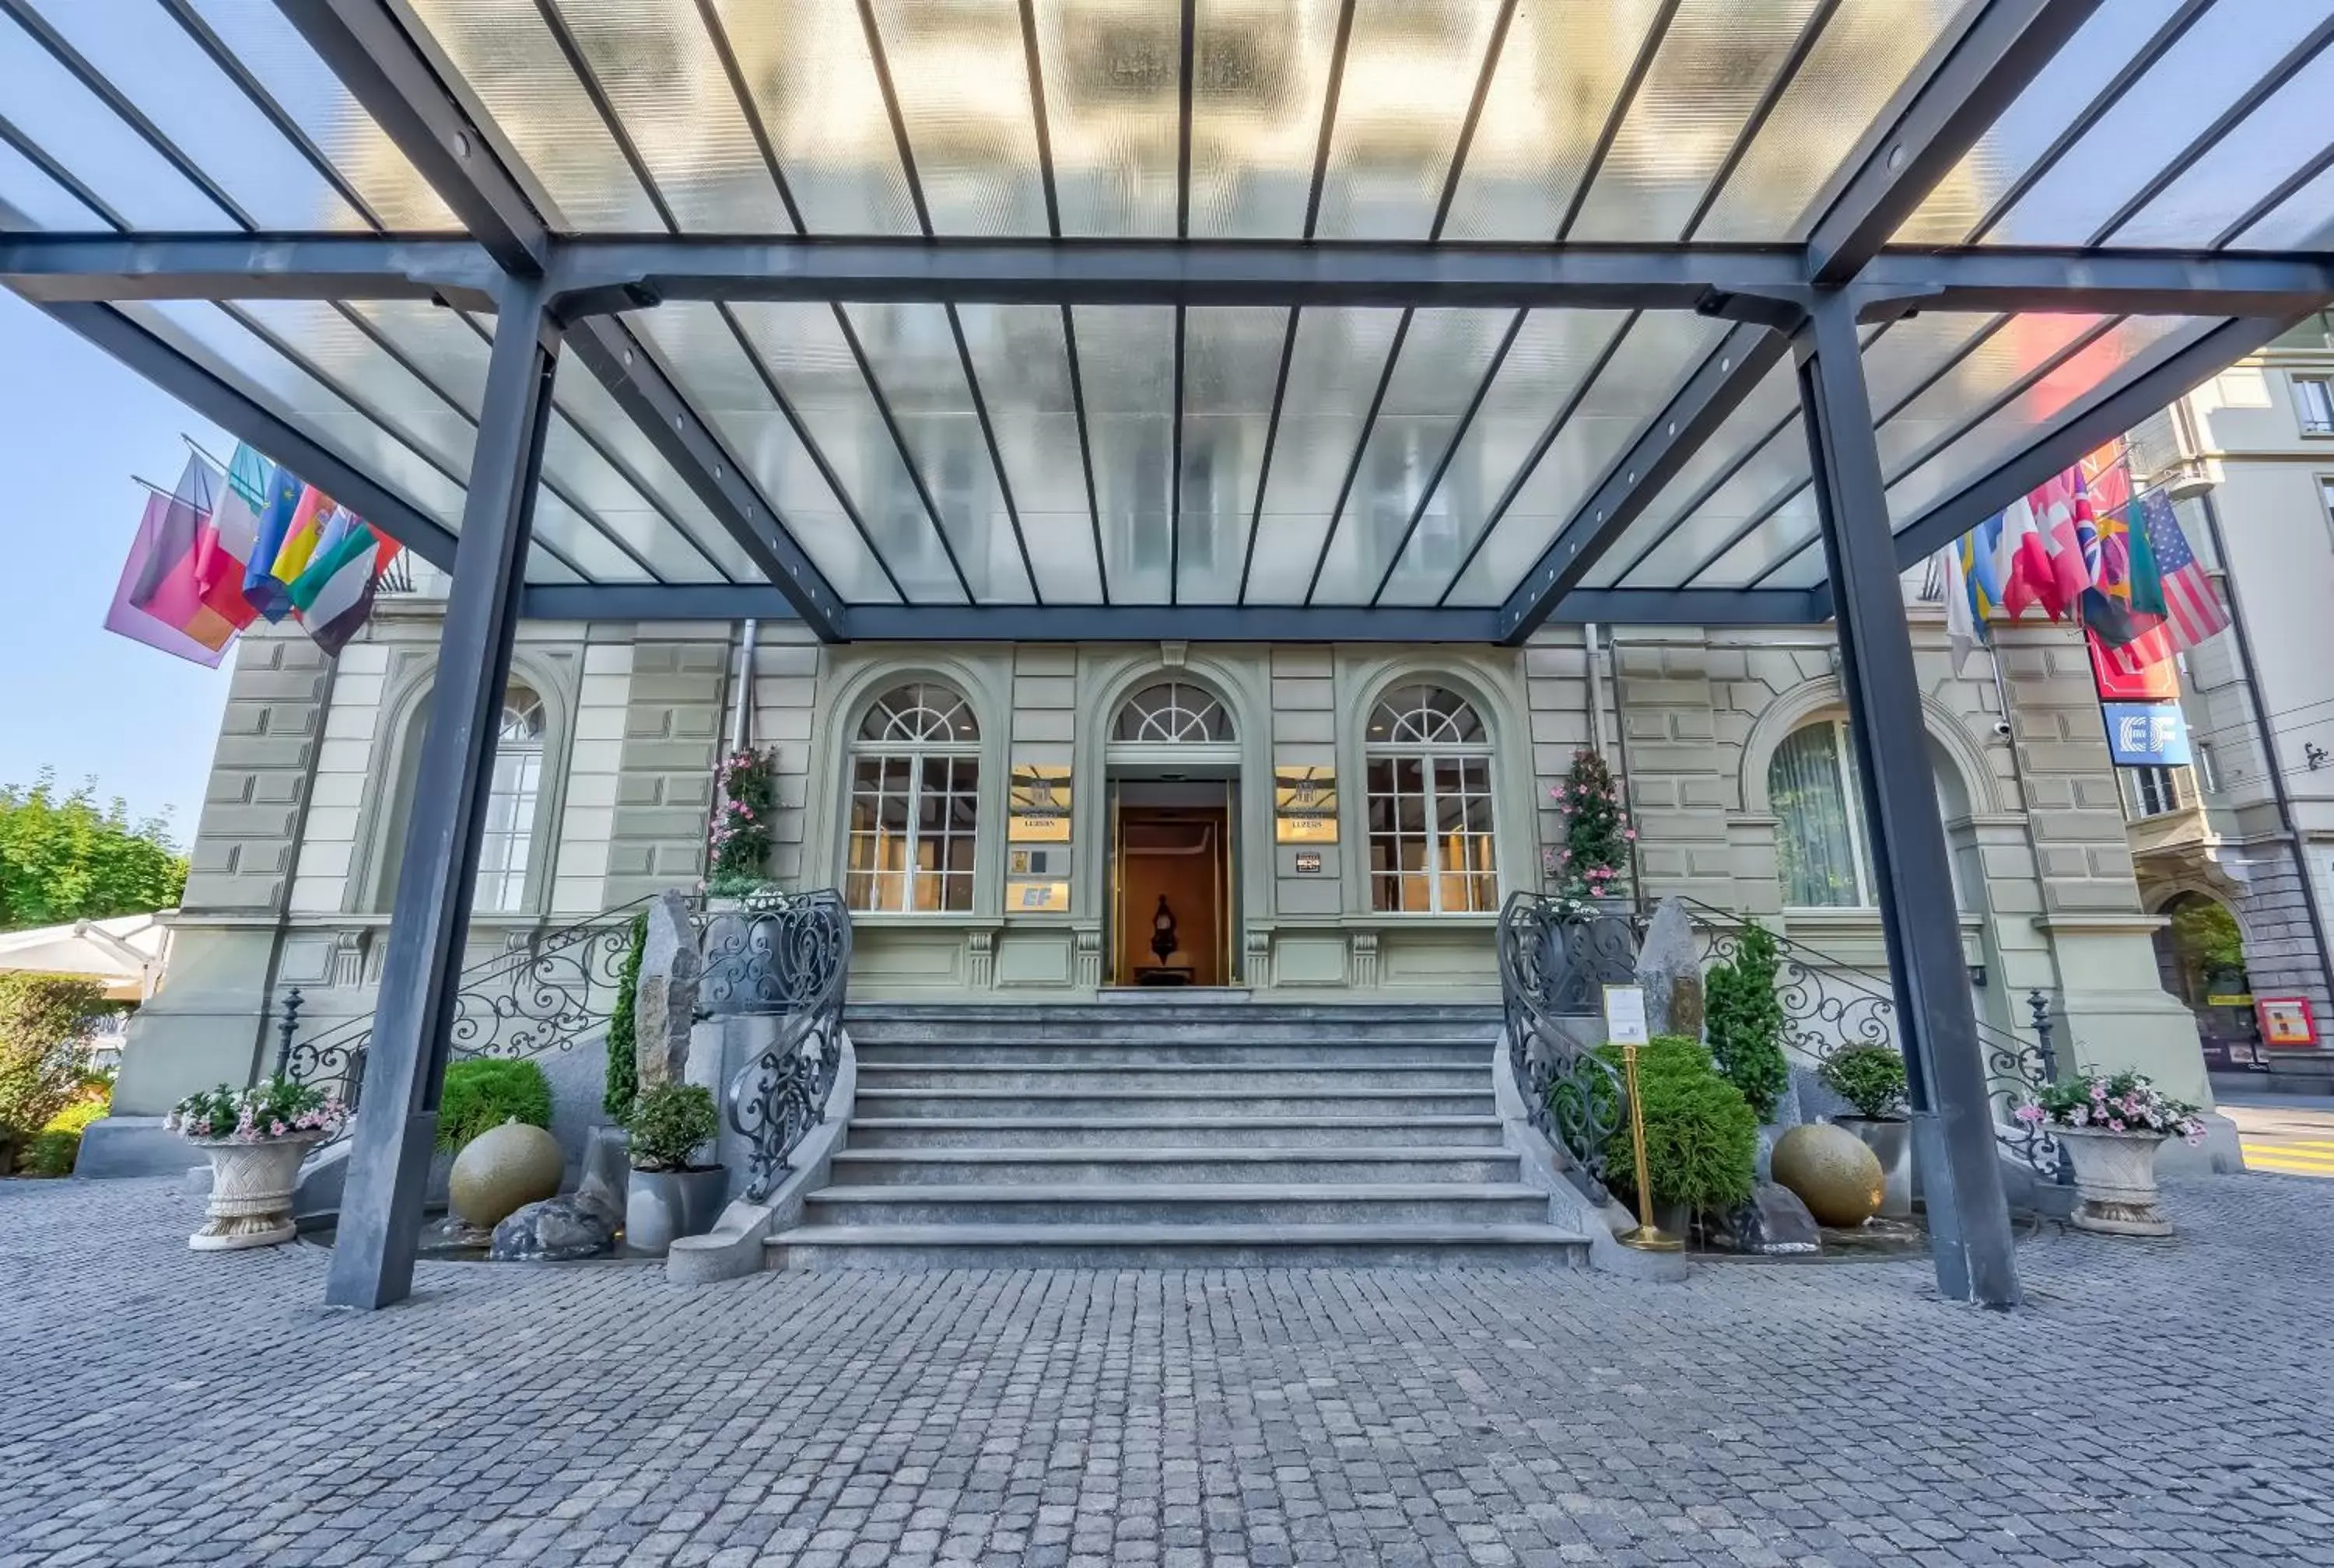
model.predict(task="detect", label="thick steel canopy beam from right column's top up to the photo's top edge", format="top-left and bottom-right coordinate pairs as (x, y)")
top-left (1807, 0), bottom-right (2101, 285)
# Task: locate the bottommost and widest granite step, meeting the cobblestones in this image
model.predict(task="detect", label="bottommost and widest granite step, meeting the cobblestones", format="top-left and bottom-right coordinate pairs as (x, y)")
top-left (766, 1220), bottom-right (1589, 1272)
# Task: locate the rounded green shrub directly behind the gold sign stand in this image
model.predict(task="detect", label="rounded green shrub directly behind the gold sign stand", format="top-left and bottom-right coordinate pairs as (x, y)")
top-left (1596, 1034), bottom-right (1758, 1213)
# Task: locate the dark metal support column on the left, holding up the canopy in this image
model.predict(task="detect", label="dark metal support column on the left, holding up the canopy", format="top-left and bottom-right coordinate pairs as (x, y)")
top-left (324, 280), bottom-right (558, 1309)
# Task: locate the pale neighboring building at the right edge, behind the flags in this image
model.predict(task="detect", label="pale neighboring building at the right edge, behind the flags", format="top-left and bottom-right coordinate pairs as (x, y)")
top-left (2122, 315), bottom-right (2334, 1083)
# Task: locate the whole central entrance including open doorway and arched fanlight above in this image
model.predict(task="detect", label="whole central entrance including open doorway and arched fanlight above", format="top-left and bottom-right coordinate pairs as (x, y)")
top-left (1102, 679), bottom-right (1239, 989)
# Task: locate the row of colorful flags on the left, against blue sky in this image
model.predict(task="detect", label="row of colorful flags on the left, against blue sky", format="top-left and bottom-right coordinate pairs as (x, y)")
top-left (105, 446), bottom-right (399, 667)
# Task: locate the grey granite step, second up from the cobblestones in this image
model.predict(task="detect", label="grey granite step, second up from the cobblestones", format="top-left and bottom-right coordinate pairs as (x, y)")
top-left (803, 1181), bottom-right (1547, 1225)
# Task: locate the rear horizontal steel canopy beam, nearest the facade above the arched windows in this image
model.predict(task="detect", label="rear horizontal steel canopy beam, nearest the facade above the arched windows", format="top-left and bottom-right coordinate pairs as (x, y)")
top-left (511, 583), bottom-right (1823, 642)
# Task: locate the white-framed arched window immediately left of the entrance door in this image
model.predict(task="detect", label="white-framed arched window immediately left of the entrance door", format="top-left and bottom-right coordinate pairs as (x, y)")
top-left (843, 681), bottom-right (980, 915)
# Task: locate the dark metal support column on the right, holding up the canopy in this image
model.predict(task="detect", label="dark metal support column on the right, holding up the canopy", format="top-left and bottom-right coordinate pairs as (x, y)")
top-left (1797, 292), bottom-right (2019, 1307)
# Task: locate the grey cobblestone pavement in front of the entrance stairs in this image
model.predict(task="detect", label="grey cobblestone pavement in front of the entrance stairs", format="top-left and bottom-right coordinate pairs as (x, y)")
top-left (0, 1176), bottom-right (2334, 1568)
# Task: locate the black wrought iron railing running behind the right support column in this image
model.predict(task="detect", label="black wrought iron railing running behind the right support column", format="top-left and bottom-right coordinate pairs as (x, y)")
top-left (1683, 898), bottom-right (2073, 1185)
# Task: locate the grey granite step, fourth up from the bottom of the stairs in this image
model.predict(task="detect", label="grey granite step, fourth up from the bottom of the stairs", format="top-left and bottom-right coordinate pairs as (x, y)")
top-left (850, 1111), bottom-right (1501, 1150)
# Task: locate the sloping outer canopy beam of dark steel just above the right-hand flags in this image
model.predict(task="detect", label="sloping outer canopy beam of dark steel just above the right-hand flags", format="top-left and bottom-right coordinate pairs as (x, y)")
top-left (1814, 310), bottom-right (2308, 616)
